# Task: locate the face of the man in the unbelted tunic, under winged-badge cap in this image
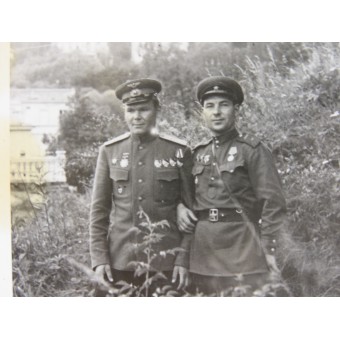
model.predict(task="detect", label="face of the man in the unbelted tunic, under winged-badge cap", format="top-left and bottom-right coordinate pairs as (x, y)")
top-left (125, 101), bottom-right (158, 135)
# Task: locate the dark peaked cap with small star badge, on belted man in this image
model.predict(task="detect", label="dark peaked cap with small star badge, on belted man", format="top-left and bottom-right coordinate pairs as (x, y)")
top-left (196, 76), bottom-right (244, 105)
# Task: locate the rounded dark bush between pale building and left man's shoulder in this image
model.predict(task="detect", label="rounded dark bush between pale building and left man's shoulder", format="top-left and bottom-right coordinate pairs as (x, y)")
top-left (58, 89), bottom-right (125, 191)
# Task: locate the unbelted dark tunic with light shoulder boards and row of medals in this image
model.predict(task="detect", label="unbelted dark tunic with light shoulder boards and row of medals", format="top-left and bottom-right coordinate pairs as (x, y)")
top-left (90, 133), bottom-right (193, 271)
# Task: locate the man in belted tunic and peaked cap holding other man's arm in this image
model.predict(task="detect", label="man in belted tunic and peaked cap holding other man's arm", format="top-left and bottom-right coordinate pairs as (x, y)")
top-left (179, 77), bottom-right (286, 294)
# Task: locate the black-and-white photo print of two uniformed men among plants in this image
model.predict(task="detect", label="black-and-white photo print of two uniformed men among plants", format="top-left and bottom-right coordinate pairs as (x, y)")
top-left (10, 42), bottom-right (340, 297)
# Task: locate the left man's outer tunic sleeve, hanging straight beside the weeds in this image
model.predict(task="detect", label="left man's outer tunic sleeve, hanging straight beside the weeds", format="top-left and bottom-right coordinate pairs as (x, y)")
top-left (90, 146), bottom-right (112, 268)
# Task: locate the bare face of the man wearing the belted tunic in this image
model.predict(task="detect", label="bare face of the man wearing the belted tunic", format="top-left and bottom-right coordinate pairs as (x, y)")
top-left (203, 95), bottom-right (239, 135)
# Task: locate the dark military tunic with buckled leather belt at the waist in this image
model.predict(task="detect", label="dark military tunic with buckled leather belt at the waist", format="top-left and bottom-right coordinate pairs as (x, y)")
top-left (190, 130), bottom-right (286, 276)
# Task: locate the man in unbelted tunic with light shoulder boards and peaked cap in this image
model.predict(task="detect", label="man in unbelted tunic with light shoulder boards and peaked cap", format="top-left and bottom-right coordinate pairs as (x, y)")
top-left (90, 79), bottom-right (193, 289)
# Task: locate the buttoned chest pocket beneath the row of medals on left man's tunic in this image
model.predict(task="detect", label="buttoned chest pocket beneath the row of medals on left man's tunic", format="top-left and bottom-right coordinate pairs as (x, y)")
top-left (155, 169), bottom-right (180, 202)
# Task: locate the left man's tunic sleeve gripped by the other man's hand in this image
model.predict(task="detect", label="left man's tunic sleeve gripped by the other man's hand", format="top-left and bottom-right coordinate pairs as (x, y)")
top-left (175, 148), bottom-right (194, 268)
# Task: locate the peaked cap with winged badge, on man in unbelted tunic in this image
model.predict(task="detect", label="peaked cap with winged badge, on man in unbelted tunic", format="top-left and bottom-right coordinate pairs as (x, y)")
top-left (115, 78), bottom-right (162, 104)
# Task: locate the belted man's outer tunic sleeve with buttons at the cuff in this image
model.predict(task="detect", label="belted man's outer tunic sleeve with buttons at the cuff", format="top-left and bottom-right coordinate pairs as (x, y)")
top-left (248, 144), bottom-right (287, 255)
